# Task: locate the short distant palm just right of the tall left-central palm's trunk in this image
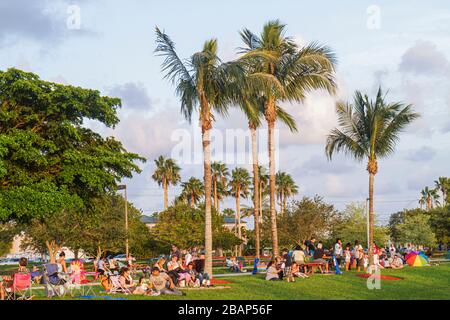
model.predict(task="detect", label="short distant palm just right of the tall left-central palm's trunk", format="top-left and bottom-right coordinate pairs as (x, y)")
top-left (229, 168), bottom-right (251, 255)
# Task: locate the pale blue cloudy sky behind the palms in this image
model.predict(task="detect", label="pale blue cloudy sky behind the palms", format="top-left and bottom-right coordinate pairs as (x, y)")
top-left (0, 0), bottom-right (450, 222)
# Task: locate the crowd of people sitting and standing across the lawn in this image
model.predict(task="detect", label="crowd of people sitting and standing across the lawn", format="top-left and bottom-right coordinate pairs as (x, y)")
top-left (0, 238), bottom-right (432, 300)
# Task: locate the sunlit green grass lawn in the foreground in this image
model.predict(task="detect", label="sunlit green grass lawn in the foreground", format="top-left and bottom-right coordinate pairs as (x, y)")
top-left (20, 264), bottom-right (450, 300)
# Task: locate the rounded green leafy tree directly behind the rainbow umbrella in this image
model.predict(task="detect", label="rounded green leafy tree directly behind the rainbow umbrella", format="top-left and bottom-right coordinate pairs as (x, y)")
top-left (398, 214), bottom-right (436, 247)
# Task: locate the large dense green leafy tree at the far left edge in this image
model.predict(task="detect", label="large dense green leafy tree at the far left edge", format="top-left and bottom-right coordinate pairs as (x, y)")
top-left (0, 69), bottom-right (144, 221)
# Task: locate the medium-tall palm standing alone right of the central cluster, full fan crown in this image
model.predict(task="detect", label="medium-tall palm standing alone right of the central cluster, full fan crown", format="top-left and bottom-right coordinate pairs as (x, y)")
top-left (325, 88), bottom-right (419, 263)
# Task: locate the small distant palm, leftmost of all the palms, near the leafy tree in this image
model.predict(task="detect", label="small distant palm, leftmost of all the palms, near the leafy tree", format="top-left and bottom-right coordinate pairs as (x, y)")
top-left (152, 156), bottom-right (181, 210)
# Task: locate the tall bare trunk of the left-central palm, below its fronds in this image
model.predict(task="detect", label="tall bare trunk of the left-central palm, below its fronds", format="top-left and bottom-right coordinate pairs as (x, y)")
top-left (202, 128), bottom-right (213, 277)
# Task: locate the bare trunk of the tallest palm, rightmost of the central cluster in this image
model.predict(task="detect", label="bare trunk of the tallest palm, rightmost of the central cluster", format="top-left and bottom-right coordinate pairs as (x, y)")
top-left (268, 121), bottom-right (279, 257)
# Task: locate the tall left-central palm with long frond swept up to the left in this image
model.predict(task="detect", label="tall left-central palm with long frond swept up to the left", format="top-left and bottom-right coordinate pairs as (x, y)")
top-left (155, 27), bottom-right (236, 275)
